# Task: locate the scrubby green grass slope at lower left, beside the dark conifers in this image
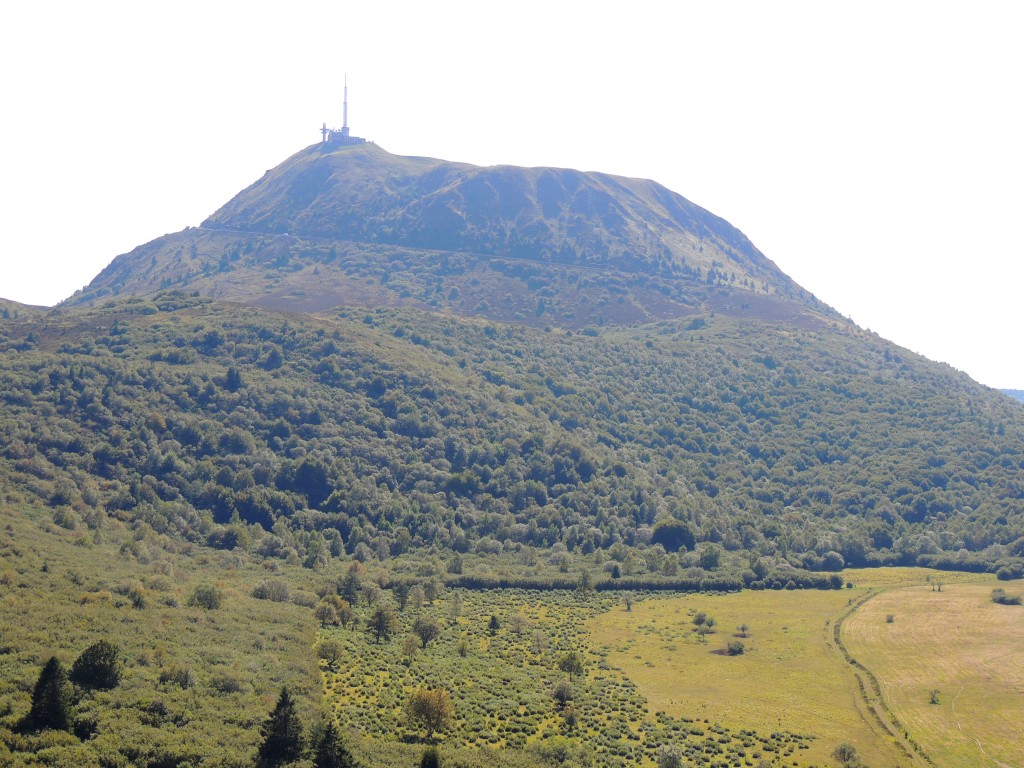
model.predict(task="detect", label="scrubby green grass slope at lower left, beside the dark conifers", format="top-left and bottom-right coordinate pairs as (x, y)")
top-left (0, 504), bottom-right (321, 767)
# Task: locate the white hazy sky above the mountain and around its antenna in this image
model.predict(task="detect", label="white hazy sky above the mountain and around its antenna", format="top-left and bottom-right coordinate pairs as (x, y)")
top-left (0, 0), bottom-right (1024, 388)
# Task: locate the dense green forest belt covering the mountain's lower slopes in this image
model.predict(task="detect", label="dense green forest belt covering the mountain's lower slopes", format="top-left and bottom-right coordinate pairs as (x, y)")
top-left (0, 294), bottom-right (1024, 586)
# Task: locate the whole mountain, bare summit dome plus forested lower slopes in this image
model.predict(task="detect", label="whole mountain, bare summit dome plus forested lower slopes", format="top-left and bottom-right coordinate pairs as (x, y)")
top-left (8, 143), bottom-right (1024, 581)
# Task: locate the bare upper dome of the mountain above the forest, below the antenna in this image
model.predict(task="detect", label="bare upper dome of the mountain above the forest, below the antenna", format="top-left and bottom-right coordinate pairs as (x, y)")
top-left (68, 143), bottom-right (838, 328)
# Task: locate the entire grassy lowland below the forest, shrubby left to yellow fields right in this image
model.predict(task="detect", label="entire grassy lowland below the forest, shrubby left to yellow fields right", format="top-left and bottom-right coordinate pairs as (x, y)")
top-left (0, 505), bottom-right (1024, 768)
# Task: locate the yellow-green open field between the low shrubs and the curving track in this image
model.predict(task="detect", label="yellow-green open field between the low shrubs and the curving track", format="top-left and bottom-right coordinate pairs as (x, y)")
top-left (589, 579), bottom-right (909, 766)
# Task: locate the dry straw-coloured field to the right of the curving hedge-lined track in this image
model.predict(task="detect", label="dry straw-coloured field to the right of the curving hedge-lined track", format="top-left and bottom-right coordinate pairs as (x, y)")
top-left (843, 581), bottom-right (1024, 768)
